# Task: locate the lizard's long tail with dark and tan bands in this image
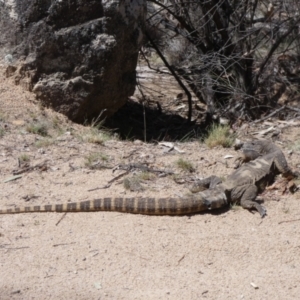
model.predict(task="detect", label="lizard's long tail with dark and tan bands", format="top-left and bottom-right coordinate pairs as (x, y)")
top-left (0, 193), bottom-right (225, 215)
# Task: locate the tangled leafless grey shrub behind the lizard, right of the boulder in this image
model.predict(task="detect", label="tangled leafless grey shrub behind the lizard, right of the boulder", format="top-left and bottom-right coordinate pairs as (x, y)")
top-left (148, 0), bottom-right (300, 120)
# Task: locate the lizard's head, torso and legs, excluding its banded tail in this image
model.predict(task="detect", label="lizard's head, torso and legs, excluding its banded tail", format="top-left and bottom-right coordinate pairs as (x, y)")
top-left (191, 140), bottom-right (296, 217)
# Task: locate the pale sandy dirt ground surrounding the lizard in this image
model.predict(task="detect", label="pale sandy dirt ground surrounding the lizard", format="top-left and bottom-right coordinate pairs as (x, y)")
top-left (0, 64), bottom-right (300, 300)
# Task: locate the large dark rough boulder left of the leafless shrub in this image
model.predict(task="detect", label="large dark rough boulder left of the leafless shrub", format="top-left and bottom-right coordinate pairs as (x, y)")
top-left (0, 0), bottom-right (146, 122)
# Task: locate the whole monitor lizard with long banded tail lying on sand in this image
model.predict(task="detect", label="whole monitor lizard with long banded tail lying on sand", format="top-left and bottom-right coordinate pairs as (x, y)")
top-left (0, 140), bottom-right (296, 217)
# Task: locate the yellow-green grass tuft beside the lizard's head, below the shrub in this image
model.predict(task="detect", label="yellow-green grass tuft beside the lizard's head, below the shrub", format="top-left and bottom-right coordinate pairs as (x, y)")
top-left (204, 125), bottom-right (235, 148)
